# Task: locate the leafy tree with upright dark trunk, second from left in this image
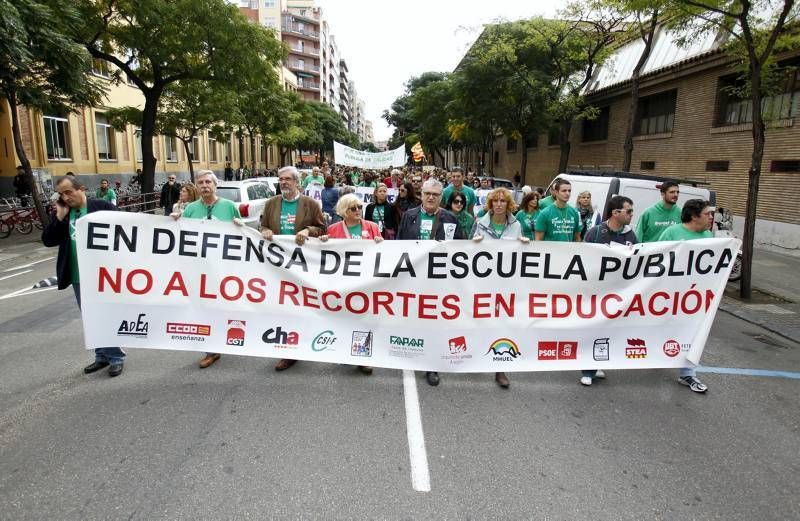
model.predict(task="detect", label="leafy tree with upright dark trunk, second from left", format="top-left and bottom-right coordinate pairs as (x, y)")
top-left (74, 0), bottom-right (283, 197)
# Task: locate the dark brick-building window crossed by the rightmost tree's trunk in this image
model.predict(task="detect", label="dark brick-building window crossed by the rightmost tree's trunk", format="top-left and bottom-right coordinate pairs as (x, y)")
top-left (716, 67), bottom-right (800, 126)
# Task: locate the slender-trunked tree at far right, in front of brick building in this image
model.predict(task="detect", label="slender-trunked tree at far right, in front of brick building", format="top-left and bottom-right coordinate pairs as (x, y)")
top-left (677, 0), bottom-right (800, 298)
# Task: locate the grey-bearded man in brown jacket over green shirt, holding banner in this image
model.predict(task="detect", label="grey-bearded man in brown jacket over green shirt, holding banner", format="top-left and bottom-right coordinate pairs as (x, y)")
top-left (261, 166), bottom-right (325, 371)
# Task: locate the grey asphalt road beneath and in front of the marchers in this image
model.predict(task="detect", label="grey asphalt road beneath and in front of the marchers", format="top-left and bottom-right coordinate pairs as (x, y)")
top-left (0, 237), bottom-right (800, 520)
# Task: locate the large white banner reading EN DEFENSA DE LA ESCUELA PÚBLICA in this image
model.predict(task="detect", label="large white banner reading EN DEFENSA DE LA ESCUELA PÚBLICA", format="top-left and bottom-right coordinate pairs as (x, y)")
top-left (77, 212), bottom-right (739, 372)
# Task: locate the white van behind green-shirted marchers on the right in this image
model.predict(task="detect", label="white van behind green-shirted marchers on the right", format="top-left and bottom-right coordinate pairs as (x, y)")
top-left (547, 172), bottom-right (716, 229)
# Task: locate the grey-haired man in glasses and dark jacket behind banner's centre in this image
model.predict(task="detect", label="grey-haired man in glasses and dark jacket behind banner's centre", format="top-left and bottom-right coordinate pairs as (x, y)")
top-left (397, 178), bottom-right (465, 386)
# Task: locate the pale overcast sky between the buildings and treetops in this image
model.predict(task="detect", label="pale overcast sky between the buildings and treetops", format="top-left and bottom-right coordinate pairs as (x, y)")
top-left (317, 0), bottom-right (566, 141)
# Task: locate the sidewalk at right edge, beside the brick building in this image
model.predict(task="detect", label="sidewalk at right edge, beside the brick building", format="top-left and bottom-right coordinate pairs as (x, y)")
top-left (719, 250), bottom-right (800, 342)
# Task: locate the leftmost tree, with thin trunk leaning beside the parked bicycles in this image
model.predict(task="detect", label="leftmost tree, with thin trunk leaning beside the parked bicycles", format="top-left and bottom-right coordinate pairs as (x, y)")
top-left (0, 0), bottom-right (103, 225)
